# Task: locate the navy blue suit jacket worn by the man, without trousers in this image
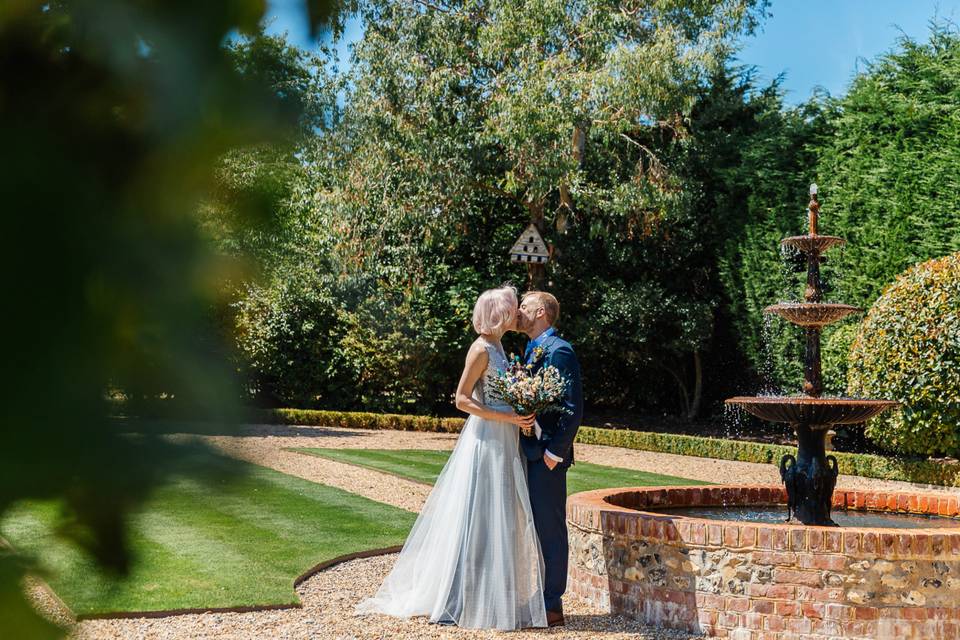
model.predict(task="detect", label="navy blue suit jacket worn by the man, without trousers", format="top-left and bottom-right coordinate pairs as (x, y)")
top-left (520, 334), bottom-right (583, 468)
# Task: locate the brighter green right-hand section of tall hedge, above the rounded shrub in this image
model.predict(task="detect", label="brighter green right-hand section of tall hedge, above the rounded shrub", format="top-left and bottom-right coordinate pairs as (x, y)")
top-left (817, 23), bottom-right (960, 392)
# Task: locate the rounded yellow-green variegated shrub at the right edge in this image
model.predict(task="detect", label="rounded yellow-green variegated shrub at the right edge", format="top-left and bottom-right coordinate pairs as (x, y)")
top-left (848, 253), bottom-right (960, 454)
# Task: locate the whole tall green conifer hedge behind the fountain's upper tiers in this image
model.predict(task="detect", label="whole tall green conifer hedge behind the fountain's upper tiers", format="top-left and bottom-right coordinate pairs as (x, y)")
top-left (724, 23), bottom-right (960, 392)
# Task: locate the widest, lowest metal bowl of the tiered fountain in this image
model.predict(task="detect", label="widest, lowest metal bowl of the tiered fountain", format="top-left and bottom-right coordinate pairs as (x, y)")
top-left (726, 396), bottom-right (899, 429)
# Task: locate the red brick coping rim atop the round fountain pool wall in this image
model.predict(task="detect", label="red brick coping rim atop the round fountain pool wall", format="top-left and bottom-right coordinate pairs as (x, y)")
top-left (567, 485), bottom-right (960, 556)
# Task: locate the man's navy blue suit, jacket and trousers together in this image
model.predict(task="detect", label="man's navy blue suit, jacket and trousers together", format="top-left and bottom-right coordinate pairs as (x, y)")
top-left (520, 335), bottom-right (583, 611)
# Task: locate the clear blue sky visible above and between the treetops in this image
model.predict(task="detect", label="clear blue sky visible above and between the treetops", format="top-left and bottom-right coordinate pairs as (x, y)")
top-left (267, 0), bottom-right (960, 104)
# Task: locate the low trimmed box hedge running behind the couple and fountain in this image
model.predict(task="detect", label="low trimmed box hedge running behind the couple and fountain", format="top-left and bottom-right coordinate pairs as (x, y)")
top-left (259, 409), bottom-right (960, 487)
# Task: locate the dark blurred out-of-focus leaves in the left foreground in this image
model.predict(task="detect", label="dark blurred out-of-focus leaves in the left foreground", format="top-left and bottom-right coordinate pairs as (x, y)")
top-left (0, 0), bottom-right (342, 638)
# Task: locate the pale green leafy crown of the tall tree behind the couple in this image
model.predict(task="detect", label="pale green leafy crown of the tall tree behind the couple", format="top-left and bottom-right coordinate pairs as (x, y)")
top-left (344, 0), bottom-right (765, 274)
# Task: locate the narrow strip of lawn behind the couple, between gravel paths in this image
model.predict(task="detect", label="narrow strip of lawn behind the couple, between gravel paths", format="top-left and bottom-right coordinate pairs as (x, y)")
top-left (293, 449), bottom-right (707, 493)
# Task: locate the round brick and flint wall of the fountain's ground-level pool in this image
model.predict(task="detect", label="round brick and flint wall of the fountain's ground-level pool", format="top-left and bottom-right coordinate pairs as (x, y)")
top-left (567, 485), bottom-right (960, 639)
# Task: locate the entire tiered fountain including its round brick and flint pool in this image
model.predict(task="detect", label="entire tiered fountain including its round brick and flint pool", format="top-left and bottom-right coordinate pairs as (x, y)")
top-left (567, 186), bottom-right (960, 640)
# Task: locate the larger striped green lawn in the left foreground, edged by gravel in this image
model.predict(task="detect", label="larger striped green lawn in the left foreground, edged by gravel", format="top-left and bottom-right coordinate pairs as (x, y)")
top-left (0, 452), bottom-right (415, 615)
